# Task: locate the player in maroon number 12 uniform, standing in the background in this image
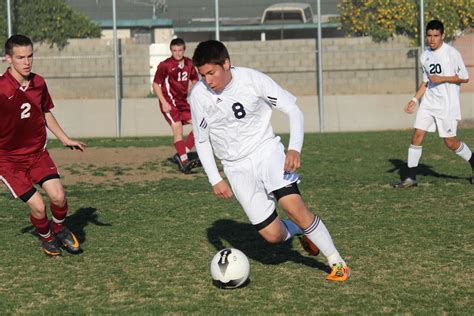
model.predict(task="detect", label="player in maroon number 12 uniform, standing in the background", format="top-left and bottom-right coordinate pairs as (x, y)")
top-left (153, 38), bottom-right (199, 173)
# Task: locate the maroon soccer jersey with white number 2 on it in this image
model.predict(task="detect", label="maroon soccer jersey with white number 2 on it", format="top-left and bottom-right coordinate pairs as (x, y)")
top-left (0, 70), bottom-right (54, 155)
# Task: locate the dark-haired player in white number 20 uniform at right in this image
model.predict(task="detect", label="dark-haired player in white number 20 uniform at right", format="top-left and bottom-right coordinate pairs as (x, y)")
top-left (395, 20), bottom-right (474, 188)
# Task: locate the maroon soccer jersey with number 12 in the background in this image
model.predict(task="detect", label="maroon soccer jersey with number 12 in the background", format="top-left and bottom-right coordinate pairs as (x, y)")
top-left (153, 57), bottom-right (198, 106)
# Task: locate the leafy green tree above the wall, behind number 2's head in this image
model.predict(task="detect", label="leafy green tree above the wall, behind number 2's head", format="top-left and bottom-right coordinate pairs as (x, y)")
top-left (0, 0), bottom-right (101, 49)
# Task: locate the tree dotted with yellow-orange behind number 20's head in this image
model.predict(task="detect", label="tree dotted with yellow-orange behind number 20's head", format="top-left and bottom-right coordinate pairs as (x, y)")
top-left (338, 0), bottom-right (474, 43)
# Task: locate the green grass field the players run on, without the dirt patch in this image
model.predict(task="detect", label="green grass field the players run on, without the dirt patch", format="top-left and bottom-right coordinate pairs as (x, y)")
top-left (0, 129), bottom-right (474, 315)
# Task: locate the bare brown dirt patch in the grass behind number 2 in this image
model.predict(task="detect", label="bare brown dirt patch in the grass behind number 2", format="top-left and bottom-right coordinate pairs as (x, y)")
top-left (49, 146), bottom-right (196, 185)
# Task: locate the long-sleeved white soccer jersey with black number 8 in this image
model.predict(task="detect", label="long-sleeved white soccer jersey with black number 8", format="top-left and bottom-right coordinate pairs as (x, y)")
top-left (189, 67), bottom-right (304, 185)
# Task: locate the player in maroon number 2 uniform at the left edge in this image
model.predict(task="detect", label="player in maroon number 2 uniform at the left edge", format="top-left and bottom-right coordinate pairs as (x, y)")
top-left (0, 35), bottom-right (85, 256)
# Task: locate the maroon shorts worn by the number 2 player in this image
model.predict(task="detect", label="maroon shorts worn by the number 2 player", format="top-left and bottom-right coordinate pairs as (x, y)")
top-left (0, 149), bottom-right (59, 200)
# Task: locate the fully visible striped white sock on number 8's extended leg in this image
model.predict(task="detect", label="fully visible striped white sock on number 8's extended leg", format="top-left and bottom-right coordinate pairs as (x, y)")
top-left (303, 216), bottom-right (346, 266)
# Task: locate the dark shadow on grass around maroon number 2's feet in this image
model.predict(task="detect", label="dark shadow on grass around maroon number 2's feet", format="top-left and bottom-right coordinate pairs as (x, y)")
top-left (20, 207), bottom-right (112, 248)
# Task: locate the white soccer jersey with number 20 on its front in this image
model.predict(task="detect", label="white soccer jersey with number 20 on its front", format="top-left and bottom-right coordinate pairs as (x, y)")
top-left (420, 43), bottom-right (469, 120)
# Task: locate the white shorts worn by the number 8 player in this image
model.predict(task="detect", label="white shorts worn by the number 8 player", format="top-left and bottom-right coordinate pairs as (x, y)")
top-left (224, 142), bottom-right (299, 225)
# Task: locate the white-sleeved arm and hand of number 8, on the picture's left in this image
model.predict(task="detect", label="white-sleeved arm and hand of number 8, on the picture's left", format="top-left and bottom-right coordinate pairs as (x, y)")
top-left (189, 92), bottom-right (233, 198)
